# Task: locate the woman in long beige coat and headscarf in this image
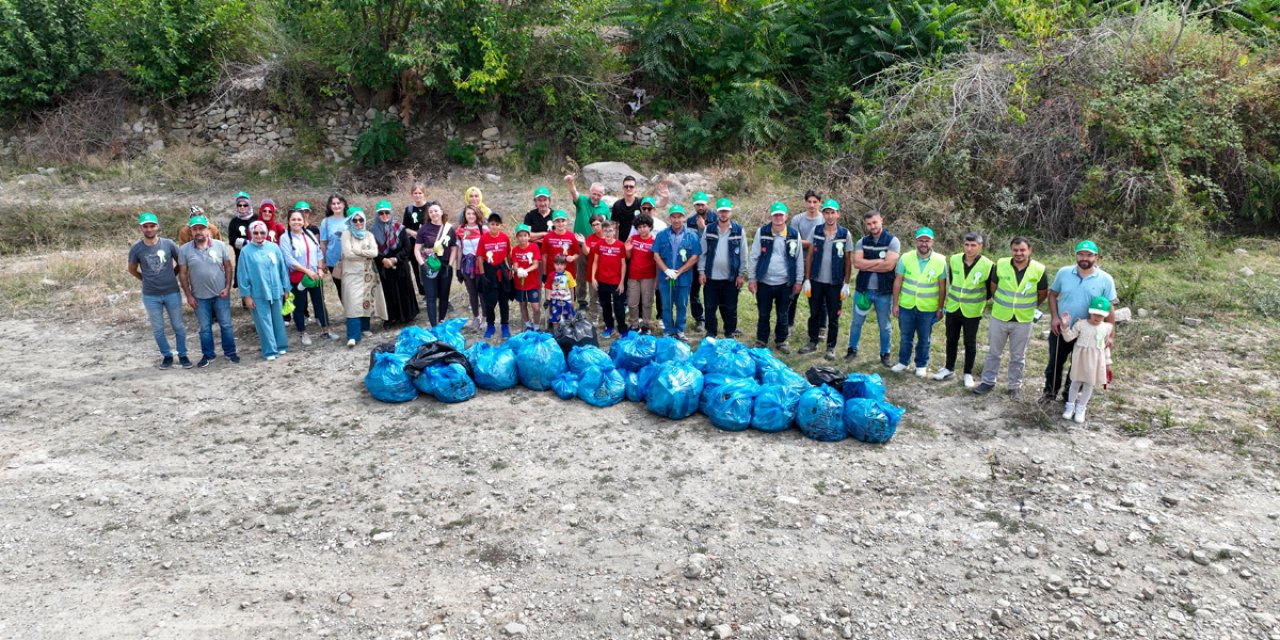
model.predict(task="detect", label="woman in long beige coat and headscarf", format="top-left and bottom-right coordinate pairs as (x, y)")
top-left (342, 207), bottom-right (387, 347)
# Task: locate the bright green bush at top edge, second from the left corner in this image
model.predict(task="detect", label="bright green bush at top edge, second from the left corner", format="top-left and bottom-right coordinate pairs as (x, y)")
top-left (91, 0), bottom-right (253, 97)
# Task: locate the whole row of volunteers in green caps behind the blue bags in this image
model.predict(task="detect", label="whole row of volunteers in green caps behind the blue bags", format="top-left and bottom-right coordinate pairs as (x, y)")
top-left (129, 174), bottom-right (1116, 422)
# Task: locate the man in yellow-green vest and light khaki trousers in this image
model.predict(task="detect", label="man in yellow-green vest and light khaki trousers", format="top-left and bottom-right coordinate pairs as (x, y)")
top-left (973, 236), bottom-right (1048, 398)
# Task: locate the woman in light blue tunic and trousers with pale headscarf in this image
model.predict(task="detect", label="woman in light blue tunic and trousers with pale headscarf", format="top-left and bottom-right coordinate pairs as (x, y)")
top-left (236, 220), bottom-right (289, 361)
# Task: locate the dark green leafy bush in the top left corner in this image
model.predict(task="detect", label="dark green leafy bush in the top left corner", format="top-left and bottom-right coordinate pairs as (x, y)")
top-left (0, 0), bottom-right (97, 113)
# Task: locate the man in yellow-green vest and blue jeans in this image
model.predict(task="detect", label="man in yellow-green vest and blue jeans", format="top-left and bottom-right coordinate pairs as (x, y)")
top-left (890, 227), bottom-right (947, 378)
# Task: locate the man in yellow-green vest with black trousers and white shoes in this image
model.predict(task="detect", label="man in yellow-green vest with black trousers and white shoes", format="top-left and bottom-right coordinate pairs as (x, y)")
top-left (933, 232), bottom-right (996, 389)
